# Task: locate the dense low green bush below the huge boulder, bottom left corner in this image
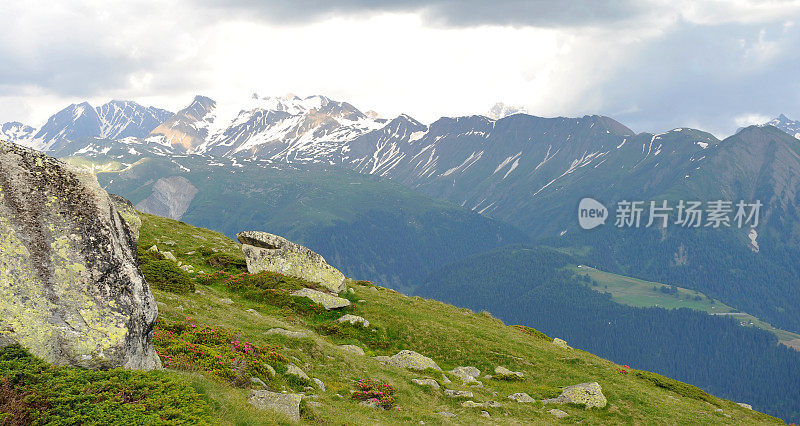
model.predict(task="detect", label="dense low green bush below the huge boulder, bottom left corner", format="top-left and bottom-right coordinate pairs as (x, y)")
top-left (0, 345), bottom-right (211, 425)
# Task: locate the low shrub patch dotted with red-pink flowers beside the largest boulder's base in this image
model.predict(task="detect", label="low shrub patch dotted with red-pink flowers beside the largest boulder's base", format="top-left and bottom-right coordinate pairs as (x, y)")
top-left (153, 317), bottom-right (287, 387)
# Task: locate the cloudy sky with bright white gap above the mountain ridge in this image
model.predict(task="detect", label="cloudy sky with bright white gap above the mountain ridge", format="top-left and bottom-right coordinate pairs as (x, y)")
top-left (0, 0), bottom-right (800, 137)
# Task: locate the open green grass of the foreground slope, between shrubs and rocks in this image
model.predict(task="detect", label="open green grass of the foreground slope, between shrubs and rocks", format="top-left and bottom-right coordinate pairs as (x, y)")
top-left (140, 215), bottom-right (779, 424)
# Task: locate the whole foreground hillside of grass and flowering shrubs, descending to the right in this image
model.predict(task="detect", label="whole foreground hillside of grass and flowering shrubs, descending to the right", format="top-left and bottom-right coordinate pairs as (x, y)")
top-left (0, 215), bottom-right (780, 424)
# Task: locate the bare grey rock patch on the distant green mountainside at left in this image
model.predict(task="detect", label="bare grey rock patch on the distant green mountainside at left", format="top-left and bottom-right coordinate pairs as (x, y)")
top-left (136, 176), bottom-right (198, 220)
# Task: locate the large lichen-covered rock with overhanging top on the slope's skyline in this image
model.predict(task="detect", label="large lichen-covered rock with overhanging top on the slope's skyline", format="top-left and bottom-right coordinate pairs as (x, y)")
top-left (236, 231), bottom-right (347, 293)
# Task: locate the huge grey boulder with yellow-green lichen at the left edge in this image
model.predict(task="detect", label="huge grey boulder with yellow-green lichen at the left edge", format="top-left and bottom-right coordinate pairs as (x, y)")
top-left (0, 142), bottom-right (160, 370)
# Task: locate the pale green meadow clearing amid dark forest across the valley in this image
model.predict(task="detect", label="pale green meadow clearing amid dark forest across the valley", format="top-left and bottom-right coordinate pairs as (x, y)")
top-left (568, 265), bottom-right (800, 351)
